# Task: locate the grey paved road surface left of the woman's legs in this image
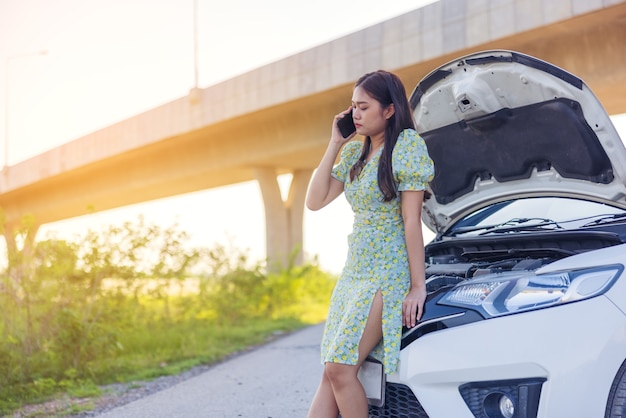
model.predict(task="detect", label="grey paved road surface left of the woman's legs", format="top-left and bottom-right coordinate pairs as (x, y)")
top-left (99, 325), bottom-right (323, 418)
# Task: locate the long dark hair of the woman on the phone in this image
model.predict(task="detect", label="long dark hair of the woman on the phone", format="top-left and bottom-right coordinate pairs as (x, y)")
top-left (350, 70), bottom-right (415, 202)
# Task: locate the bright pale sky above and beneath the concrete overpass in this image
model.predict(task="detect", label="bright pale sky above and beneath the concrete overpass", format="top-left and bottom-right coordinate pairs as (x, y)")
top-left (0, 0), bottom-right (626, 272)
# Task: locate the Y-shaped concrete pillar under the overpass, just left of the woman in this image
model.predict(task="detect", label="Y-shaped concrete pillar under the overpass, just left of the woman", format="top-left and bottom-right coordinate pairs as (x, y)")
top-left (255, 168), bottom-right (313, 271)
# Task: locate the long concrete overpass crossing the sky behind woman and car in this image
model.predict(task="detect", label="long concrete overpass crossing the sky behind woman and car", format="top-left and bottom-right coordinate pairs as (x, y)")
top-left (0, 0), bottom-right (626, 261)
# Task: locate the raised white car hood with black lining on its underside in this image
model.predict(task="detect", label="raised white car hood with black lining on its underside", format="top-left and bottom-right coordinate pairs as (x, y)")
top-left (410, 50), bottom-right (626, 234)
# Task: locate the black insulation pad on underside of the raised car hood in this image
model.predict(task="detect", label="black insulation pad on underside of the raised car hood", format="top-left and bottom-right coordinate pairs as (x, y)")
top-left (423, 98), bottom-right (614, 204)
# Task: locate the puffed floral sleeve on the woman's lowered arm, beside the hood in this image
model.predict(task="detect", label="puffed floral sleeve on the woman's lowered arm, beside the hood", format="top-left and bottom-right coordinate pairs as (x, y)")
top-left (392, 129), bottom-right (435, 191)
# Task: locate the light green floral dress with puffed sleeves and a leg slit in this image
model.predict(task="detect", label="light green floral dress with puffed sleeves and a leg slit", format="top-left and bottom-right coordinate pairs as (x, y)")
top-left (321, 129), bottom-right (433, 373)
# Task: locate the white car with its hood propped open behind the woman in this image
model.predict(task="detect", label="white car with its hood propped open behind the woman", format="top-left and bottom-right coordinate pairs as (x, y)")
top-left (364, 51), bottom-right (626, 418)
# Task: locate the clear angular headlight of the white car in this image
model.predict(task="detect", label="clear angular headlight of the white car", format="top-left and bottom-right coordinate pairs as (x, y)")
top-left (438, 265), bottom-right (624, 317)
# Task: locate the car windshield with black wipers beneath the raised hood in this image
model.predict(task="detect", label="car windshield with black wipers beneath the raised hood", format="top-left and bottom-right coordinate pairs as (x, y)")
top-left (444, 197), bottom-right (626, 236)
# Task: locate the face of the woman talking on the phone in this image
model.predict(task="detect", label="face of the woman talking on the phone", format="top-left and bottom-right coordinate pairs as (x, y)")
top-left (352, 86), bottom-right (393, 139)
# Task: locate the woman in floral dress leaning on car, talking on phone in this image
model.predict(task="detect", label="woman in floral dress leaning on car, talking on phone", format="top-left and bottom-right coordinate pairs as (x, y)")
top-left (306, 70), bottom-right (433, 418)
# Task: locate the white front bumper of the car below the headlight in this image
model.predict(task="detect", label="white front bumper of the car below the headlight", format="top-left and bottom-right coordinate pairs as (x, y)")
top-left (380, 296), bottom-right (626, 418)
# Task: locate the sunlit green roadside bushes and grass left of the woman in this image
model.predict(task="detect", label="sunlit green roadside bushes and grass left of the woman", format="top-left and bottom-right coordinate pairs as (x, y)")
top-left (0, 218), bottom-right (335, 413)
